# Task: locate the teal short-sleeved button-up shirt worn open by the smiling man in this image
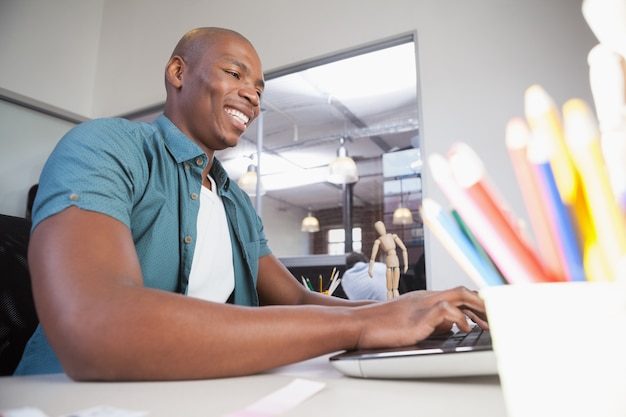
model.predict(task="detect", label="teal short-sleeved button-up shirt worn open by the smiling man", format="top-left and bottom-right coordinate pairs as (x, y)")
top-left (15, 116), bottom-right (271, 375)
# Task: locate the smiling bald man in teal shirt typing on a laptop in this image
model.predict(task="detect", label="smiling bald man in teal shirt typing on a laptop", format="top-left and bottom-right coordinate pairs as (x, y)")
top-left (16, 28), bottom-right (487, 380)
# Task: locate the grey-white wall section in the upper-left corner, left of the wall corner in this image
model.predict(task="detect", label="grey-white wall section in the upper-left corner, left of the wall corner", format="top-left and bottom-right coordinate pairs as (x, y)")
top-left (0, 0), bottom-right (103, 116)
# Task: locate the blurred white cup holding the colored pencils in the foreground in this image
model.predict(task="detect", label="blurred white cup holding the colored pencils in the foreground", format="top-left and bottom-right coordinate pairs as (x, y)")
top-left (480, 282), bottom-right (626, 417)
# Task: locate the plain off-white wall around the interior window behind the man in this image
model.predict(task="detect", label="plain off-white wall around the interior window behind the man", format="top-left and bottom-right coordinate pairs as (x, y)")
top-left (0, 0), bottom-right (596, 288)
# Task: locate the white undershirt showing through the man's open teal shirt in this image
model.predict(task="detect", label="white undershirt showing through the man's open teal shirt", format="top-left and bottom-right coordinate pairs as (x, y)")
top-left (187, 177), bottom-right (235, 303)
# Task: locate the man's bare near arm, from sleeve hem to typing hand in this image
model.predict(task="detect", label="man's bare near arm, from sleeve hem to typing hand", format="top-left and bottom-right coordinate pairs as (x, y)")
top-left (29, 208), bottom-right (484, 380)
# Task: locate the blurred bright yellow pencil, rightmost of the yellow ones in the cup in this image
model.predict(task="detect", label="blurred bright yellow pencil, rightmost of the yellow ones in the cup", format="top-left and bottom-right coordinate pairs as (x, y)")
top-left (563, 99), bottom-right (626, 279)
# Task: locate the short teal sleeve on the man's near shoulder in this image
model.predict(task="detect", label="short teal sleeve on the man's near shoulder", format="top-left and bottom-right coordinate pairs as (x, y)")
top-left (32, 119), bottom-right (147, 229)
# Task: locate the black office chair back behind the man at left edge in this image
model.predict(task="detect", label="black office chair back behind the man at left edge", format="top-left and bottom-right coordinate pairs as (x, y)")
top-left (0, 214), bottom-right (39, 375)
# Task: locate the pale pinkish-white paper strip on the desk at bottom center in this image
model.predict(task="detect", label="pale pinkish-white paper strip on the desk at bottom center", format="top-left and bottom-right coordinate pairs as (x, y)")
top-left (224, 378), bottom-right (326, 417)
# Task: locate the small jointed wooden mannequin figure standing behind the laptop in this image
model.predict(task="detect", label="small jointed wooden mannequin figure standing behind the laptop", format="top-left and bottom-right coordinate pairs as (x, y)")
top-left (367, 221), bottom-right (409, 299)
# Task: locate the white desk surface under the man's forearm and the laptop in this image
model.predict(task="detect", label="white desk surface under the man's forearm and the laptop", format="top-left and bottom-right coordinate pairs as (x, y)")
top-left (0, 356), bottom-right (506, 417)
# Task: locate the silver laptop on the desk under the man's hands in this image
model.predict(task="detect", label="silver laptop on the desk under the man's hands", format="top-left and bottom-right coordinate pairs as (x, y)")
top-left (329, 325), bottom-right (498, 379)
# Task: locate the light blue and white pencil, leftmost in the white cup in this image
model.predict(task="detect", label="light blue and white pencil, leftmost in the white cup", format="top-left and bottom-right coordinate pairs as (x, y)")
top-left (420, 198), bottom-right (506, 288)
